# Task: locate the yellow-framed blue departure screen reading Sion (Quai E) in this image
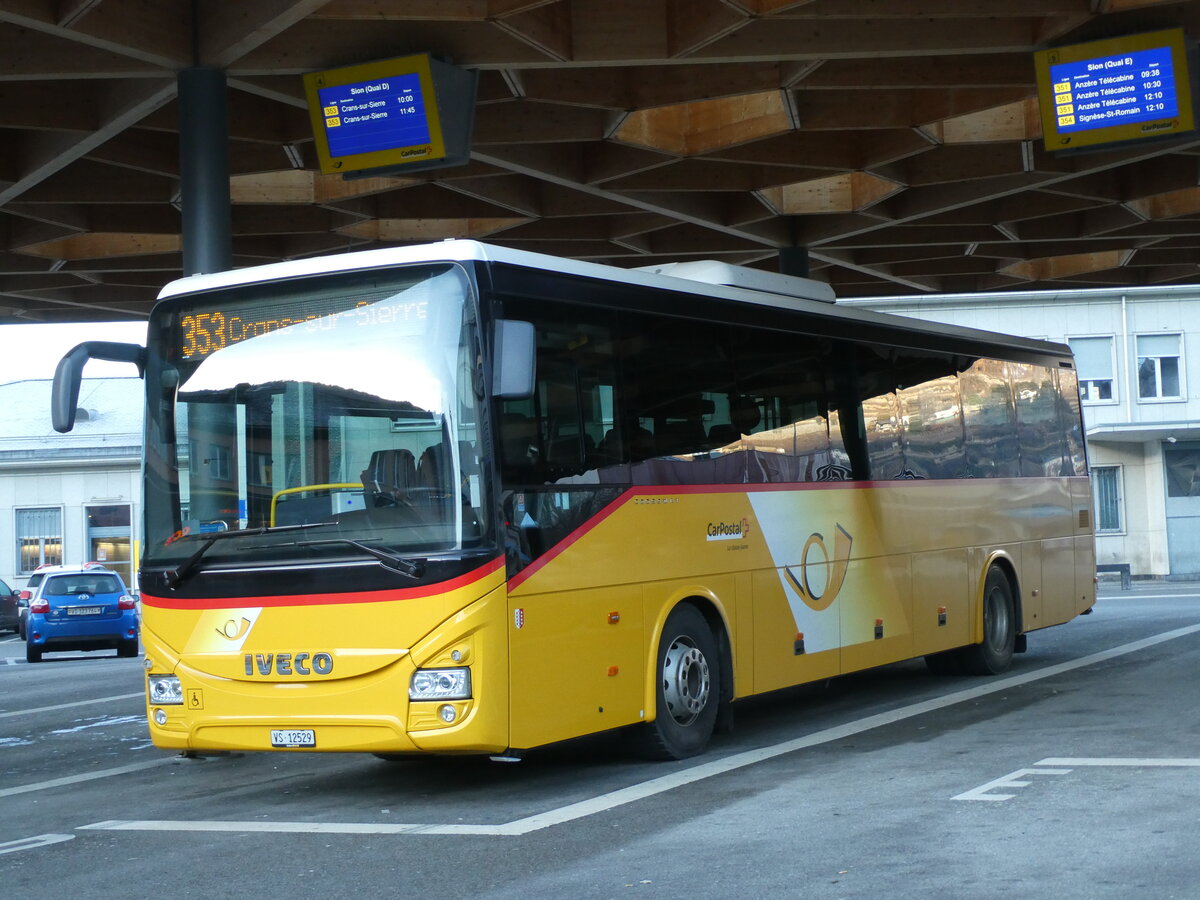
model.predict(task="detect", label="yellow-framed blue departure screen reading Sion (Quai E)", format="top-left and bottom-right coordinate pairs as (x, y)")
top-left (1036, 29), bottom-right (1195, 150)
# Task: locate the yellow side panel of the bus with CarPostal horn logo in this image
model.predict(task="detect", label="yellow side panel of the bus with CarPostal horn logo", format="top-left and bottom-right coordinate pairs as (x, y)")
top-left (509, 478), bottom-right (1094, 746)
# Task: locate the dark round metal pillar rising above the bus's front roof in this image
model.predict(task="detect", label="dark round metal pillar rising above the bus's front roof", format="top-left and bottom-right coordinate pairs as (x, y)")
top-left (179, 66), bottom-right (233, 275)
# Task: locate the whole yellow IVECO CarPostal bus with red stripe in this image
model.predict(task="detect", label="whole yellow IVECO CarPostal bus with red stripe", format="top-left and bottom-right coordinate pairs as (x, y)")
top-left (53, 241), bottom-right (1096, 758)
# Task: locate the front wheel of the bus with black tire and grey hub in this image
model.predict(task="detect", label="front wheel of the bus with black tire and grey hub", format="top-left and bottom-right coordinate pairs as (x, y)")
top-left (638, 604), bottom-right (721, 760)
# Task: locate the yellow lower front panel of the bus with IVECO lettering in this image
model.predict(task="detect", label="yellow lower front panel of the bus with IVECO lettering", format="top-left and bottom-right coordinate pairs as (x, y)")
top-left (142, 564), bottom-right (509, 754)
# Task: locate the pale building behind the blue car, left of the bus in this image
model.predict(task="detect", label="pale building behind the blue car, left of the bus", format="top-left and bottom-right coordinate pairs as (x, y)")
top-left (0, 378), bottom-right (143, 588)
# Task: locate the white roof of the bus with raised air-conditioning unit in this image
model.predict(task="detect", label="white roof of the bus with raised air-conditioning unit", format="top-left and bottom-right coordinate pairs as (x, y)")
top-left (158, 240), bottom-right (1070, 367)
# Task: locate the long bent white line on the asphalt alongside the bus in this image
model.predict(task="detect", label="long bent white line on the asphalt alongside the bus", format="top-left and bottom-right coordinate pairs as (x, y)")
top-left (77, 624), bottom-right (1200, 836)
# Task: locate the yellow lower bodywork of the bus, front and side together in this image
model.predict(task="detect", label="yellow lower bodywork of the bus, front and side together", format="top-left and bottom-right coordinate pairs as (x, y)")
top-left (143, 478), bottom-right (1094, 754)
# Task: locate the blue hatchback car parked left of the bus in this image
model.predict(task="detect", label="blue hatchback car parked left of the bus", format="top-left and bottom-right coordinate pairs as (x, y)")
top-left (25, 564), bottom-right (138, 662)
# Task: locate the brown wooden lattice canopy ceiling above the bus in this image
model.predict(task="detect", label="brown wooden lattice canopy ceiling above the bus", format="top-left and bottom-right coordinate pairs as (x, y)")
top-left (0, 0), bottom-right (1200, 323)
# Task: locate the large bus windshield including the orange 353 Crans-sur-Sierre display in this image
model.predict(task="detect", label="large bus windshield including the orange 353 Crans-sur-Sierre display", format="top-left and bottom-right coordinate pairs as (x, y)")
top-left (145, 265), bottom-right (487, 565)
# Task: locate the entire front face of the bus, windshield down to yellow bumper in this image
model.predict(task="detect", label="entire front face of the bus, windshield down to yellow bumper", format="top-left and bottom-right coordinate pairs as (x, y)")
top-left (51, 254), bottom-right (532, 752)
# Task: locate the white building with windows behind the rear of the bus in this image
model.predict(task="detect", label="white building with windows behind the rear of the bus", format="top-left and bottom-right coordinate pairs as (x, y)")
top-left (839, 286), bottom-right (1200, 578)
